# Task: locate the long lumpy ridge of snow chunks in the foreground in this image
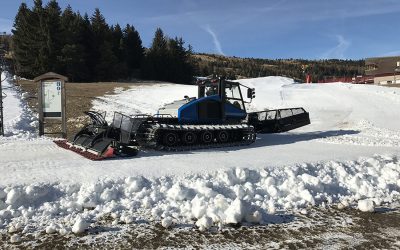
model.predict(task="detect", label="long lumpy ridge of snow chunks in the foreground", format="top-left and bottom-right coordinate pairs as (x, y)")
top-left (0, 155), bottom-right (400, 234)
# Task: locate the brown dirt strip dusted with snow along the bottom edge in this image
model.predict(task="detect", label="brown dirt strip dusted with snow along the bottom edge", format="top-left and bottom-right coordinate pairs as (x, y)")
top-left (0, 207), bottom-right (400, 249)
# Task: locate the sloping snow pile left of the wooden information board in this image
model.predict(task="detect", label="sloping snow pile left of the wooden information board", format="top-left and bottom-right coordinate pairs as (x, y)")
top-left (1, 72), bottom-right (38, 140)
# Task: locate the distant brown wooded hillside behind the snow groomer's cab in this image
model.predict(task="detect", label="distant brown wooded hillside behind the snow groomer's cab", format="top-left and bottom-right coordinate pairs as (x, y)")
top-left (193, 53), bottom-right (365, 82)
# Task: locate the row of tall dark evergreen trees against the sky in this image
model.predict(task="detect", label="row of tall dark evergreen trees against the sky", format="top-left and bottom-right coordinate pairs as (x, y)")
top-left (12, 0), bottom-right (193, 82)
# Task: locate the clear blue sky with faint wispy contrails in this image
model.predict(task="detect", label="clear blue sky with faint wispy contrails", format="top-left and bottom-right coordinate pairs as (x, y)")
top-left (0, 0), bottom-right (400, 59)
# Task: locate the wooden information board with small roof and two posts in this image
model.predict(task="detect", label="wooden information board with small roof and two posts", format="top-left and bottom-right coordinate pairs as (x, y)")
top-left (34, 72), bottom-right (68, 138)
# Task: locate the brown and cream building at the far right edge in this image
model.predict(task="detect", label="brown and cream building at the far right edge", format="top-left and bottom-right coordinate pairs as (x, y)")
top-left (365, 56), bottom-right (400, 85)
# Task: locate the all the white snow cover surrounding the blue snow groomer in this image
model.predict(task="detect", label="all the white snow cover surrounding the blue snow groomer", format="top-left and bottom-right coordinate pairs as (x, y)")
top-left (0, 72), bottom-right (400, 240)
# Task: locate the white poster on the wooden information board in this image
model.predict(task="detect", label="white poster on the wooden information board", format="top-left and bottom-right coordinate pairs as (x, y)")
top-left (42, 81), bottom-right (62, 118)
